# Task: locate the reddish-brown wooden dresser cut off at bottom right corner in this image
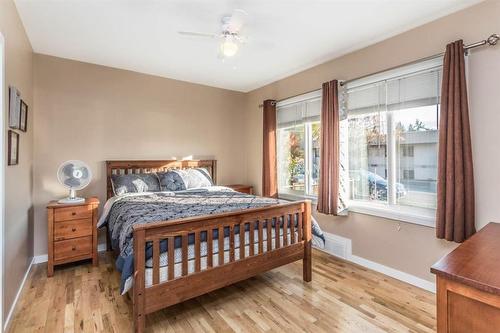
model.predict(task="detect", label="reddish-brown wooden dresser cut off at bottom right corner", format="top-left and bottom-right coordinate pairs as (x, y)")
top-left (431, 223), bottom-right (500, 333)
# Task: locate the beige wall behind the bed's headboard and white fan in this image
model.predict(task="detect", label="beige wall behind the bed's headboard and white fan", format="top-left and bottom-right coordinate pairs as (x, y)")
top-left (34, 55), bottom-right (246, 255)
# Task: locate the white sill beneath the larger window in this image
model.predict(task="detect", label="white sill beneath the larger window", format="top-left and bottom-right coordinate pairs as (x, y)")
top-left (349, 202), bottom-right (436, 228)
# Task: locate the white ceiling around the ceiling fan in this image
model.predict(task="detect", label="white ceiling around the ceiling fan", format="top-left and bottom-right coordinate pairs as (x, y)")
top-left (15, 0), bottom-right (480, 92)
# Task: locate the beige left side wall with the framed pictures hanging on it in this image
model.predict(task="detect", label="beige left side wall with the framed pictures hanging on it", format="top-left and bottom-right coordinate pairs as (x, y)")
top-left (0, 0), bottom-right (35, 319)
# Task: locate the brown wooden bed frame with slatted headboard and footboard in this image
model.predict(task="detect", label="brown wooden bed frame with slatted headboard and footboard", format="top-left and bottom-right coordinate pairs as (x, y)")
top-left (106, 160), bottom-right (311, 332)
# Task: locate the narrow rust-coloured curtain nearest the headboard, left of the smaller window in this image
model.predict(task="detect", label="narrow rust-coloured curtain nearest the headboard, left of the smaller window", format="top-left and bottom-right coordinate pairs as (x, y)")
top-left (262, 99), bottom-right (278, 198)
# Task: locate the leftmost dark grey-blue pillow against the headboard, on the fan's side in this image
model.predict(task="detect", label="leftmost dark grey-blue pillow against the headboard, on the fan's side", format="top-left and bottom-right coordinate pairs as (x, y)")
top-left (111, 173), bottom-right (160, 195)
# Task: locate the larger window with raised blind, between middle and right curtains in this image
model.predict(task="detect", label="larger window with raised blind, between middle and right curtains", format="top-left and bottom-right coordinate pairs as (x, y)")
top-left (343, 59), bottom-right (442, 225)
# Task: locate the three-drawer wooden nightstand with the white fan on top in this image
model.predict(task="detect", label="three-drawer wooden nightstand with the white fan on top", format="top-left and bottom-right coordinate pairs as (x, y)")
top-left (47, 198), bottom-right (99, 277)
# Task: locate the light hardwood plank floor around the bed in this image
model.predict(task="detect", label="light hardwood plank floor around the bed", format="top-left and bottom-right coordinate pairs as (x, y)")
top-left (9, 250), bottom-right (436, 333)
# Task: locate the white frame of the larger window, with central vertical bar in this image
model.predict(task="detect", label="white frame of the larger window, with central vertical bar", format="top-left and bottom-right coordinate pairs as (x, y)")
top-left (343, 57), bottom-right (443, 228)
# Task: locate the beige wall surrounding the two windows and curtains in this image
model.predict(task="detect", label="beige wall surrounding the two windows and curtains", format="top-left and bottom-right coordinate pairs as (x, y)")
top-left (245, 0), bottom-right (500, 280)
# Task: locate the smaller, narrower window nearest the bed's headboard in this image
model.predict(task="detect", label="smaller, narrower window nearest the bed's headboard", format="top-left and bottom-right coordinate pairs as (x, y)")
top-left (276, 91), bottom-right (321, 198)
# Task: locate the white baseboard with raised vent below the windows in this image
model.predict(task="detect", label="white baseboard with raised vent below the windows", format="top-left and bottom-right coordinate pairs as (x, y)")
top-left (319, 232), bottom-right (436, 293)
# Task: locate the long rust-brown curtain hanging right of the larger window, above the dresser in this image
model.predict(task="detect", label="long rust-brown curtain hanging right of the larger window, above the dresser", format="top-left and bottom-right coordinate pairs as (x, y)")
top-left (436, 40), bottom-right (476, 243)
